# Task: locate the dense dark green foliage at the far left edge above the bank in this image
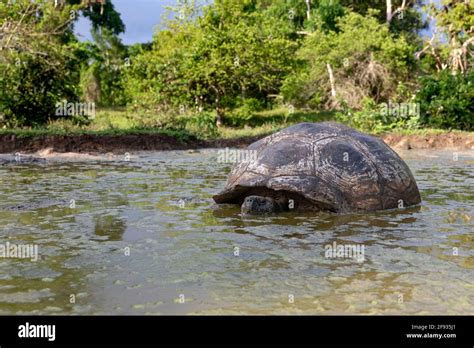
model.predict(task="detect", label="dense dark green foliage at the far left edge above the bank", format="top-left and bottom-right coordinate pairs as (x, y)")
top-left (0, 0), bottom-right (83, 126)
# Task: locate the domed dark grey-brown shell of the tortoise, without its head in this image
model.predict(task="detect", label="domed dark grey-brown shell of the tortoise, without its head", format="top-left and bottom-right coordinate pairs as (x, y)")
top-left (213, 122), bottom-right (421, 212)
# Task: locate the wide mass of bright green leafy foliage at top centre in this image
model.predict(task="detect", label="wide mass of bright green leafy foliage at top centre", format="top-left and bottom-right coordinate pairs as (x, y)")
top-left (126, 0), bottom-right (297, 121)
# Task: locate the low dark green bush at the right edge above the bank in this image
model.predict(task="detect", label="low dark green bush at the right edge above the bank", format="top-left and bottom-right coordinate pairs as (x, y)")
top-left (416, 70), bottom-right (474, 130)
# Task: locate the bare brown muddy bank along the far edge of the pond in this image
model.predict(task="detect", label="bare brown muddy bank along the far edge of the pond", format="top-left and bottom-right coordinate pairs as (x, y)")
top-left (0, 132), bottom-right (474, 153)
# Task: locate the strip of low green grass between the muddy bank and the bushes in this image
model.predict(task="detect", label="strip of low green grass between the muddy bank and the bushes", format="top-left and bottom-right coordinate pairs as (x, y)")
top-left (0, 108), bottom-right (474, 141)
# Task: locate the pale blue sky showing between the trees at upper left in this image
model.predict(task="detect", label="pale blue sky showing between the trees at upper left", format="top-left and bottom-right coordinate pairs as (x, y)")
top-left (75, 0), bottom-right (176, 45)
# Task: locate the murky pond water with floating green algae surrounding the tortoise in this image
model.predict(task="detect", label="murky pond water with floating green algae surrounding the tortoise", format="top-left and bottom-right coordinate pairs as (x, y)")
top-left (0, 150), bottom-right (474, 314)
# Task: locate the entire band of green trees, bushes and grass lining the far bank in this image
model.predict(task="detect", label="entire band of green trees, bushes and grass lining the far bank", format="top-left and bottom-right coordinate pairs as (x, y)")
top-left (0, 0), bottom-right (474, 138)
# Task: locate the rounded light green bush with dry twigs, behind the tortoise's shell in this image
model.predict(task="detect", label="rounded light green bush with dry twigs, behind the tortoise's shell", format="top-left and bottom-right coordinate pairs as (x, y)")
top-left (282, 13), bottom-right (414, 108)
